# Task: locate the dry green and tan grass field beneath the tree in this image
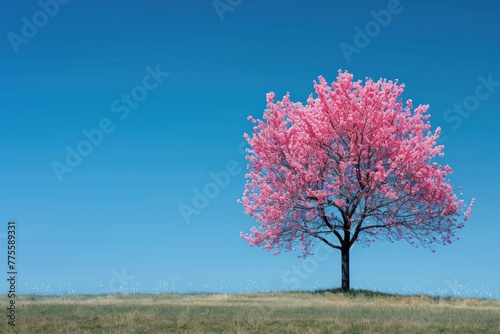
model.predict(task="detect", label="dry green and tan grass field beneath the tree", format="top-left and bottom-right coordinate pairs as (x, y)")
top-left (0, 291), bottom-right (500, 333)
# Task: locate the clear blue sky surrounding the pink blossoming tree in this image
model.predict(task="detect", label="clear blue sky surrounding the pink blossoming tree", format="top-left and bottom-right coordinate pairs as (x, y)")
top-left (0, 0), bottom-right (500, 298)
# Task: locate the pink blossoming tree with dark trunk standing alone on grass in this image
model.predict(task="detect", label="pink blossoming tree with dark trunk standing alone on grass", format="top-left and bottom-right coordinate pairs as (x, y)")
top-left (240, 70), bottom-right (474, 291)
